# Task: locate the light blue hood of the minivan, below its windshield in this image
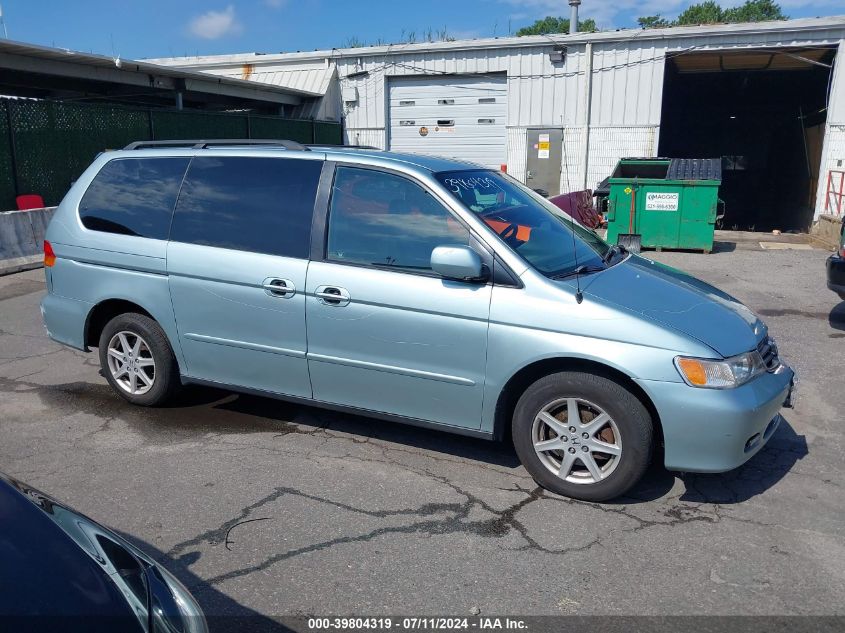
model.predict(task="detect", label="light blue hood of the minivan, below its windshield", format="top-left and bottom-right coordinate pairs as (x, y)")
top-left (582, 256), bottom-right (766, 357)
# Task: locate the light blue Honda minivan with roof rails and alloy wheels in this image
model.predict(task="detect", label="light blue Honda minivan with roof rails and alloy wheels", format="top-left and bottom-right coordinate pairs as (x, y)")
top-left (42, 141), bottom-right (793, 500)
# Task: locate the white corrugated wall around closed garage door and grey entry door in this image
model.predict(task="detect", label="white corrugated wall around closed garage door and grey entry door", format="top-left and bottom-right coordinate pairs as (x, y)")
top-left (337, 43), bottom-right (666, 191)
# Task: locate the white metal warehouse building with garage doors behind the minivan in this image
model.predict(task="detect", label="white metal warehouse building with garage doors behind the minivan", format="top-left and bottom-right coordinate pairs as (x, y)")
top-left (153, 17), bottom-right (845, 230)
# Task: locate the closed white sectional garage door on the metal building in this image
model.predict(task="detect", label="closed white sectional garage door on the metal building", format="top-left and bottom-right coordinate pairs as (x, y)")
top-left (389, 76), bottom-right (508, 168)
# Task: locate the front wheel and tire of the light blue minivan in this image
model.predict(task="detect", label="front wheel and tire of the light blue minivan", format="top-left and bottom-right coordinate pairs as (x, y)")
top-left (512, 372), bottom-right (653, 501)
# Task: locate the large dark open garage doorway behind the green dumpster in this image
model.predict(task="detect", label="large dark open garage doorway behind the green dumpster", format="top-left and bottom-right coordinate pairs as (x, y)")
top-left (658, 47), bottom-right (836, 231)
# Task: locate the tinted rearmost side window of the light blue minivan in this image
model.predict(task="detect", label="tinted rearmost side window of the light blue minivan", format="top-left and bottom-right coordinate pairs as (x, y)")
top-left (79, 158), bottom-right (189, 240)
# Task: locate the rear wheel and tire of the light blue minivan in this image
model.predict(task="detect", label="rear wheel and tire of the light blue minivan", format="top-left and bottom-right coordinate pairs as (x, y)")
top-left (99, 312), bottom-right (181, 407)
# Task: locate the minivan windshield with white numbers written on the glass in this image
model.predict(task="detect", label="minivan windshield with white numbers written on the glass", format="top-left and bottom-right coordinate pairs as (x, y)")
top-left (435, 169), bottom-right (610, 277)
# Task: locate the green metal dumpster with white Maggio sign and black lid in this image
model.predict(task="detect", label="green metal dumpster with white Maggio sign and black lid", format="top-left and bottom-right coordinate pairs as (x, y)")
top-left (607, 158), bottom-right (722, 253)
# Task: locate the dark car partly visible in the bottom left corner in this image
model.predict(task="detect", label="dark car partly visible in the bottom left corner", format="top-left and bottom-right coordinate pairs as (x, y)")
top-left (0, 473), bottom-right (207, 633)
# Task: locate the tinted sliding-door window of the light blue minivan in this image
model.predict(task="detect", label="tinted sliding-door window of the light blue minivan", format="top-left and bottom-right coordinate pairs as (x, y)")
top-left (170, 156), bottom-right (323, 259)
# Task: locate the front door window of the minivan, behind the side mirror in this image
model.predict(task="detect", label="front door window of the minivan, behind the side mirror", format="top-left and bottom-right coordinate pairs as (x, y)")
top-left (328, 167), bottom-right (469, 271)
